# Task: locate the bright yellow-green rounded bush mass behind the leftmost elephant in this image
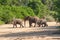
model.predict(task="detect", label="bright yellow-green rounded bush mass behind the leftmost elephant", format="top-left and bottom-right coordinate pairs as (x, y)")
top-left (0, 6), bottom-right (34, 23)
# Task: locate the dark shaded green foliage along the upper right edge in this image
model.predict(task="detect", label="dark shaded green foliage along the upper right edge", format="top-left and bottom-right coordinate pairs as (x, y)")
top-left (53, 0), bottom-right (60, 21)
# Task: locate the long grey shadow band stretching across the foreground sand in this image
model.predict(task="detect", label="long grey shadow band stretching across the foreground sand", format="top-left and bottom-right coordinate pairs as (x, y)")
top-left (0, 31), bottom-right (60, 37)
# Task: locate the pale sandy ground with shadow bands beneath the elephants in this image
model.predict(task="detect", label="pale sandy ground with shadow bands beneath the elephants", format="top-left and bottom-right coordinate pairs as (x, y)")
top-left (0, 22), bottom-right (60, 40)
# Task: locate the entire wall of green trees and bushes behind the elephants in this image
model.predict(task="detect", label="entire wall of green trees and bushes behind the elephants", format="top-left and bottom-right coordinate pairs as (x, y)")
top-left (0, 0), bottom-right (60, 24)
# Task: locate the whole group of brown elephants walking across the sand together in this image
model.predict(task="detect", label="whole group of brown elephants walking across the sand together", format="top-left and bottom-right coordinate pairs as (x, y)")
top-left (13, 16), bottom-right (48, 28)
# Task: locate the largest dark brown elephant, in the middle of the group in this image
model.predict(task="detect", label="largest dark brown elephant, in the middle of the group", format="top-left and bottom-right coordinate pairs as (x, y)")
top-left (24, 16), bottom-right (39, 27)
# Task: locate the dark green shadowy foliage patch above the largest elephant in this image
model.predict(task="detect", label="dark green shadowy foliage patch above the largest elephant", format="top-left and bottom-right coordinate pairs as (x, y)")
top-left (28, 1), bottom-right (42, 15)
